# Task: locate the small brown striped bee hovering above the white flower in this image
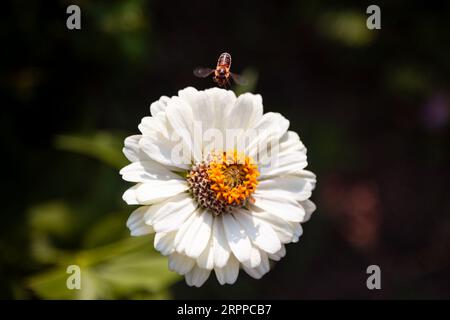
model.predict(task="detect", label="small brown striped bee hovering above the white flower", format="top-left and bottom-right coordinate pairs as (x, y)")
top-left (194, 52), bottom-right (247, 87)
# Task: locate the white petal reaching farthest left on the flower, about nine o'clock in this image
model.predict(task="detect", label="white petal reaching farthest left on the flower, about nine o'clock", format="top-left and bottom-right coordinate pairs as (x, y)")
top-left (120, 159), bottom-right (184, 182)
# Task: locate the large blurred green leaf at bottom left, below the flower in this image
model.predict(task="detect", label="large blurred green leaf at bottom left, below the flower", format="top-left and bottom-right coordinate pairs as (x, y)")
top-left (28, 237), bottom-right (180, 299)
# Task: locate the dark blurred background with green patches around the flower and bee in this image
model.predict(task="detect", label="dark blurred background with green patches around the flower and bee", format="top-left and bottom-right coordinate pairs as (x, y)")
top-left (0, 0), bottom-right (450, 299)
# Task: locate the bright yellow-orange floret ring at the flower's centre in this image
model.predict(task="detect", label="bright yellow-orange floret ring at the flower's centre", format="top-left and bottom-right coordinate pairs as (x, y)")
top-left (207, 151), bottom-right (259, 205)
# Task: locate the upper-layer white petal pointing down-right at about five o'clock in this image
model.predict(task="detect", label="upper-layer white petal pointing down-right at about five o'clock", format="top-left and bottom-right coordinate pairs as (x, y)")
top-left (235, 209), bottom-right (281, 253)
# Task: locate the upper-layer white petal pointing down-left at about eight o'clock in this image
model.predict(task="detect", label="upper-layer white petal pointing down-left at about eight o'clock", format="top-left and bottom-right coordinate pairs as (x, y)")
top-left (149, 193), bottom-right (197, 232)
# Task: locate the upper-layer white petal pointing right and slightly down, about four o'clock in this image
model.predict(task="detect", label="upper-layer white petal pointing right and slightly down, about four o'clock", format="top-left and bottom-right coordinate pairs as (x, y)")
top-left (254, 193), bottom-right (305, 222)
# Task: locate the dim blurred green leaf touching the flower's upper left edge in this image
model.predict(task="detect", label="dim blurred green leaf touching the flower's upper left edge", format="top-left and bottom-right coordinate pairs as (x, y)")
top-left (55, 132), bottom-right (128, 168)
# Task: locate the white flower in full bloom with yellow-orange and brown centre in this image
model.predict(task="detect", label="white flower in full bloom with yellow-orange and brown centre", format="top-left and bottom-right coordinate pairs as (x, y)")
top-left (120, 87), bottom-right (316, 287)
